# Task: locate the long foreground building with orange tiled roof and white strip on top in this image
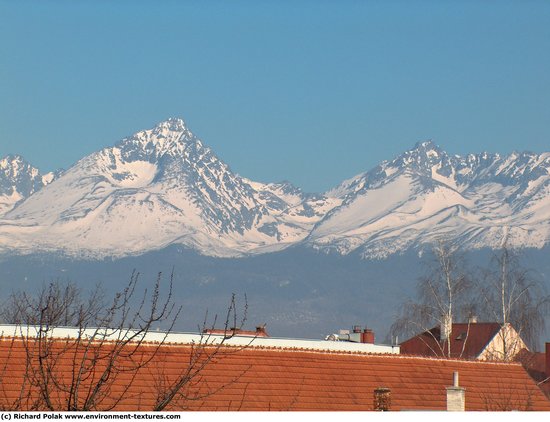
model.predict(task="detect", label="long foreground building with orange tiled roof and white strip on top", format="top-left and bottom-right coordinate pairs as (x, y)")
top-left (0, 326), bottom-right (550, 411)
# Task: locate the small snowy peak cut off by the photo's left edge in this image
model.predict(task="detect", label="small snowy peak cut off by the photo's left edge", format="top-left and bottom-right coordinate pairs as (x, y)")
top-left (0, 155), bottom-right (59, 216)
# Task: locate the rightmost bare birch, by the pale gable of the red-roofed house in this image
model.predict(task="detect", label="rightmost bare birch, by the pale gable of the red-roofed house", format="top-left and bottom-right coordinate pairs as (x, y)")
top-left (476, 246), bottom-right (550, 360)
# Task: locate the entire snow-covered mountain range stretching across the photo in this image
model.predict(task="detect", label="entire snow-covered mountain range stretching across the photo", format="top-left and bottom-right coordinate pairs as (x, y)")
top-left (0, 119), bottom-right (550, 258)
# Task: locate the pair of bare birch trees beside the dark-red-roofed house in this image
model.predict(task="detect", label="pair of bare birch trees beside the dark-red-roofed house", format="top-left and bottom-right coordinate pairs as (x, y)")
top-left (390, 241), bottom-right (550, 360)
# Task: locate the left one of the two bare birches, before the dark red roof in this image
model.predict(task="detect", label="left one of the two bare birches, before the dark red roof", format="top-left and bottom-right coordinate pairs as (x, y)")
top-left (391, 241), bottom-right (472, 356)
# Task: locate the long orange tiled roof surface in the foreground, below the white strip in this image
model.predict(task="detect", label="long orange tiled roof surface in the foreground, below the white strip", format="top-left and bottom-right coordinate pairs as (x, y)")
top-left (0, 339), bottom-right (550, 411)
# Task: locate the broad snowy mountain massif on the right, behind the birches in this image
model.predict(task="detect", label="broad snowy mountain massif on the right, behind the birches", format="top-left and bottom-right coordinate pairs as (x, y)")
top-left (307, 141), bottom-right (550, 257)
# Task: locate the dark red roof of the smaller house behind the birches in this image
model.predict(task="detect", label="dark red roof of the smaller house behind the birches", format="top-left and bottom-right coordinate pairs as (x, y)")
top-left (400, 322), bottom-right (500, 359)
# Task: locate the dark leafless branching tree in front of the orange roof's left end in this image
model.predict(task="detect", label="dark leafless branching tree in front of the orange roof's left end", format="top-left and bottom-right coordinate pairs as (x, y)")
top-left (0, 273), bottom-right (250, 411)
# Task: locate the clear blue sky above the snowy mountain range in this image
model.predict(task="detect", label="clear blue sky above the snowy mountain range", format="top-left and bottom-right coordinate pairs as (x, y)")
top-left (0, 0), bottom-right (550, 191)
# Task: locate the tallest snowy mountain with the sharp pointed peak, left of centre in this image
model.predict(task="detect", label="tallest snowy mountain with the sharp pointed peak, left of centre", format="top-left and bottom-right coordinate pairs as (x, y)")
top-left (0, 119), bottom-right (332, 257)
